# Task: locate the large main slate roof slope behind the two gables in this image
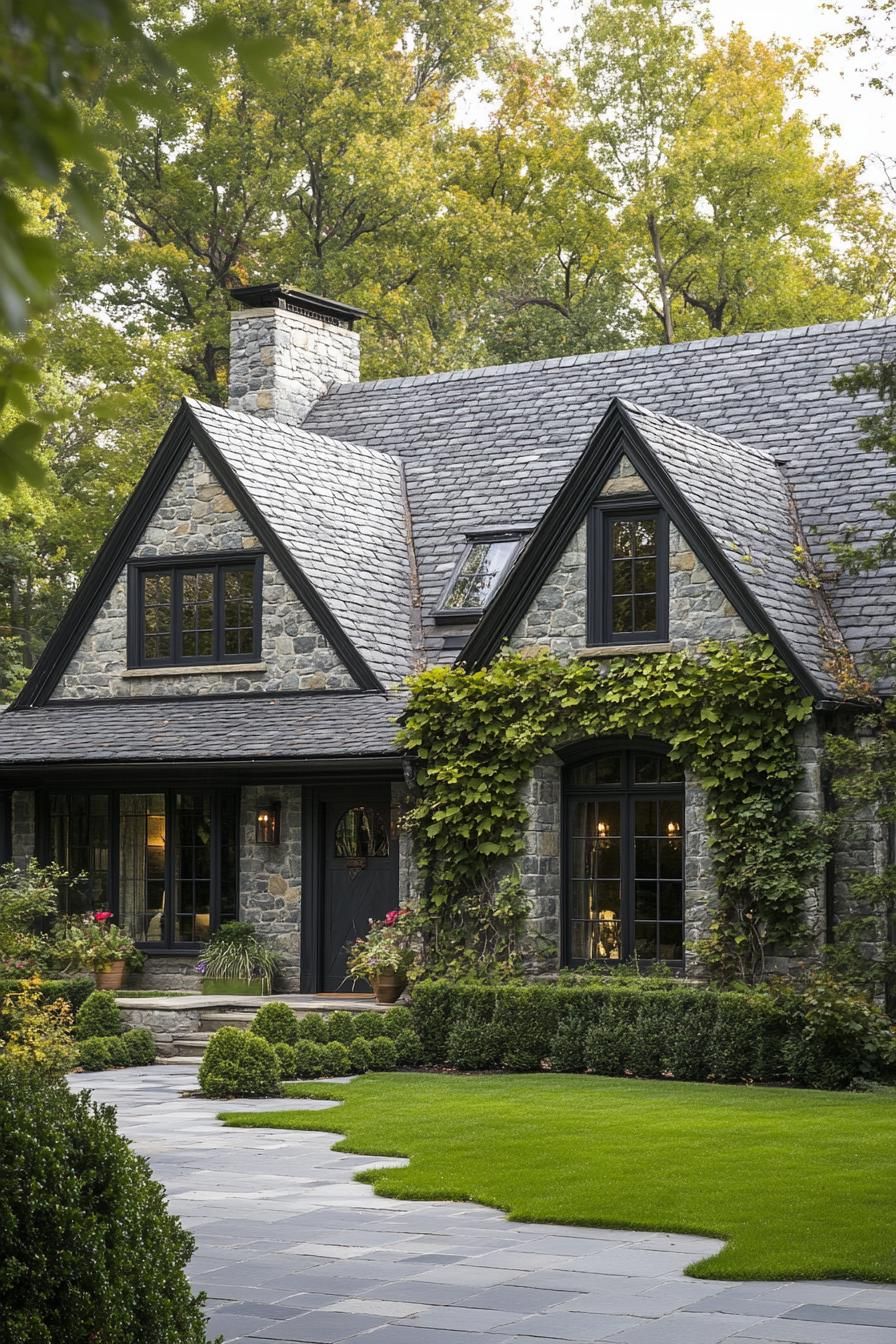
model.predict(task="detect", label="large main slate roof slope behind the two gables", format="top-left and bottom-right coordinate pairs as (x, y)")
top-left (305, 319), bottom-right (896, 672)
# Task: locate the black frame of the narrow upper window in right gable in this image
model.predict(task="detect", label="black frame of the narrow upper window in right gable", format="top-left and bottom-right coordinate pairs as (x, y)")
top-left (587, 495), bottom-right (669, 648)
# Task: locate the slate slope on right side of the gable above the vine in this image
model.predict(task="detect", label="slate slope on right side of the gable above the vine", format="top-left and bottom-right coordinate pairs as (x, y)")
top-left (622, 402), bottom-right (836, 692)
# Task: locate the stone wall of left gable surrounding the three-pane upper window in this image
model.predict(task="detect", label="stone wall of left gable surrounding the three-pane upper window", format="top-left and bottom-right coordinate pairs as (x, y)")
top-left (52, 448), bottom-right (356, 699)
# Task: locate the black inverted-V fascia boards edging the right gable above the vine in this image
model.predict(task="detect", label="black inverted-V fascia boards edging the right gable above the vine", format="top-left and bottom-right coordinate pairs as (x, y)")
top-left (458, 396), bottom-right (829, 700)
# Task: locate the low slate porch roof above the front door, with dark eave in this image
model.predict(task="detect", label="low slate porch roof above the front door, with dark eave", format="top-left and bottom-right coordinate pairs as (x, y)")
top-left (0, 692), bottom-right (404, 788)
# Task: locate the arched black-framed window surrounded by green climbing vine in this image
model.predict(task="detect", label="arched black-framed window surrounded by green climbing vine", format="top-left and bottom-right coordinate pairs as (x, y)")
top-left (564, 746), bottom-right (685, 965)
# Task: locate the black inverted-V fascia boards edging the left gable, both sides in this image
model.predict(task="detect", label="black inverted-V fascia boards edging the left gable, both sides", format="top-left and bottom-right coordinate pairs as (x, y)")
top-left (14, 401), bottom-right (384, 712)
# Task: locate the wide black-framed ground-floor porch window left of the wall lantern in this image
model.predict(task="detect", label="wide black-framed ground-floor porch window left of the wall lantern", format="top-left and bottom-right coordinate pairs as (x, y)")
top-left (39, 788), bottom-right (239, 952)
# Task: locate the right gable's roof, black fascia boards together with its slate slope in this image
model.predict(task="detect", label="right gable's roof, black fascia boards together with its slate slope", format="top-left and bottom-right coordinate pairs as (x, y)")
top-left (461, 399), bottom-right (834, 696)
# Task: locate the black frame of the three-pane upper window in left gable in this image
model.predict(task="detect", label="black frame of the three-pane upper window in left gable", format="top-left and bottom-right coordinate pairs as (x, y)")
top-left (128, 550), bottom-right (265, 669)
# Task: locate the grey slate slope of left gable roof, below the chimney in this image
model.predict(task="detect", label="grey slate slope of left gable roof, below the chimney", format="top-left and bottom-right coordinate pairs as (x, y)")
top-left (187, 398), bottom-right (412, 687)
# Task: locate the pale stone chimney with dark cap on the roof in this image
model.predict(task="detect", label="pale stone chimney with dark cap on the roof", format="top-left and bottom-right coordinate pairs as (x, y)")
top-left (228, 285), bottom-right (364, 425)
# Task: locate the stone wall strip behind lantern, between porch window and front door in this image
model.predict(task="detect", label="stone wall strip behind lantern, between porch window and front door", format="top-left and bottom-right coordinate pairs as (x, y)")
top-left (239, 784), bottom-right (302, 993)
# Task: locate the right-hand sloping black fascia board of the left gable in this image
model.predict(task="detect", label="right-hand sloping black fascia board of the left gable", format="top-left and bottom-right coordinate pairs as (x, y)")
top-left (184, 402), bottom-right (386, 691)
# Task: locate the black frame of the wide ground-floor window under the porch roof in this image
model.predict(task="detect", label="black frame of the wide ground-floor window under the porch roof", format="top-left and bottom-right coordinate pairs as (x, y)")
top-left (35, 781), bottom-right (242, 958)
